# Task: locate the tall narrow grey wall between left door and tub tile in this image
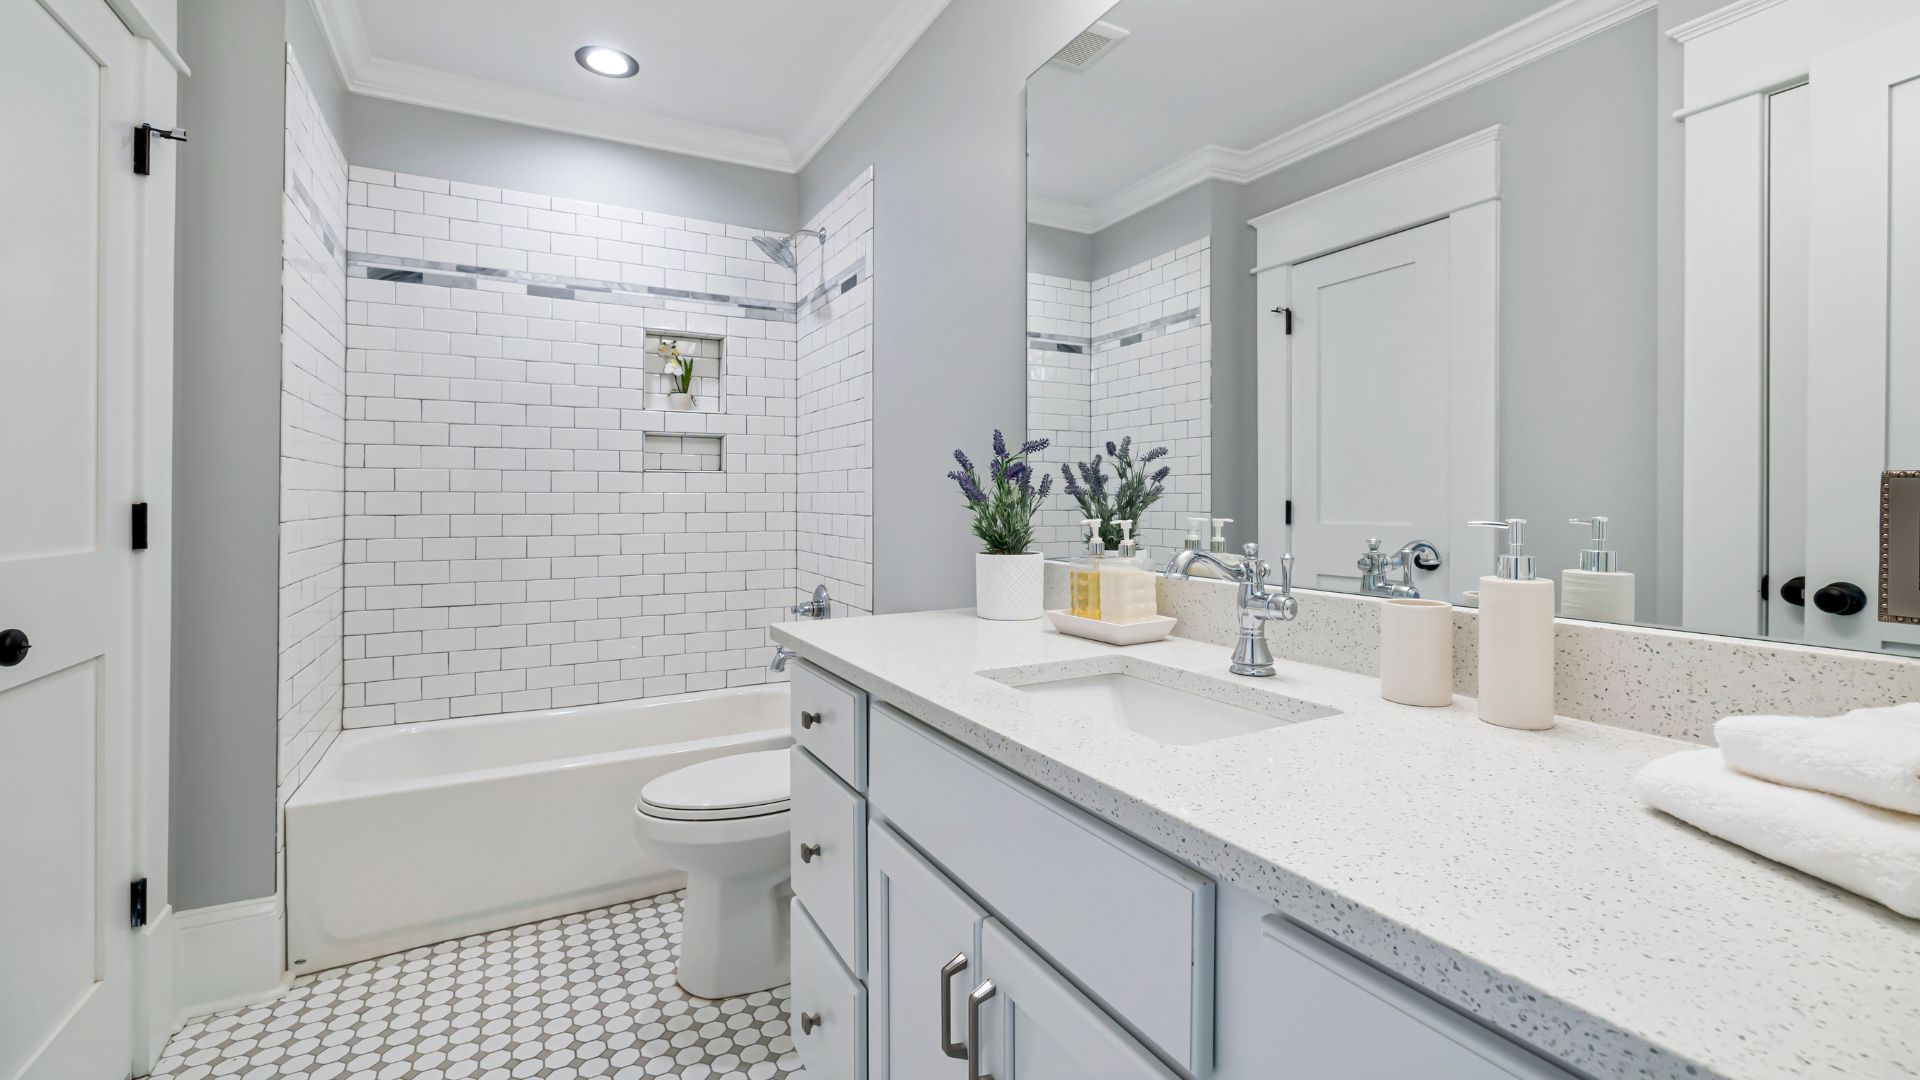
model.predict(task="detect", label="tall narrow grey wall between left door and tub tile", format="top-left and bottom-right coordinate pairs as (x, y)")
top-left (171, 0), bottom-right (286, 909)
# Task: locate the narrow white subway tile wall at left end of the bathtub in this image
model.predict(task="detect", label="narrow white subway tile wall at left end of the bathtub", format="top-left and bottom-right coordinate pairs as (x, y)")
top-left (278, 52), bottom-right (348, 803)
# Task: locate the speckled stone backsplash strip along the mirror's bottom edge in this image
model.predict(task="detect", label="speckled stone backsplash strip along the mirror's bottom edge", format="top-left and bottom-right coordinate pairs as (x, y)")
top-left (1046, 563), bottom-right (1920, 744)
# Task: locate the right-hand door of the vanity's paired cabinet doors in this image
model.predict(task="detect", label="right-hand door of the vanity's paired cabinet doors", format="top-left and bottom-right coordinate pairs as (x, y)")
top-left (975, 919), bottom-right (1177, 1080)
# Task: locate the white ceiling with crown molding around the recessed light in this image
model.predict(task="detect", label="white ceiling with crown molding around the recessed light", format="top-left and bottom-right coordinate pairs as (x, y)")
top-left (315, 0), bottom-right (948, 171)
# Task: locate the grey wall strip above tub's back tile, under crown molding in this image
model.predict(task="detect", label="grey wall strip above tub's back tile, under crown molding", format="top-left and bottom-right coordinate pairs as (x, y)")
top-left (346, 94), bottom-right (798, 231)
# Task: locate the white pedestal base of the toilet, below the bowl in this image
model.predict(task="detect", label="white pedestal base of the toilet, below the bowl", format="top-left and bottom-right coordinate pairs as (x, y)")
top-left (678, 865), bottom-right (793, 997)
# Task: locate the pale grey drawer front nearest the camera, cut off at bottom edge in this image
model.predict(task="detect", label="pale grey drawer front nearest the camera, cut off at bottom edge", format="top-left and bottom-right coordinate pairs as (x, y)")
top-left (1260, 915), bottom-right (1574, 1080)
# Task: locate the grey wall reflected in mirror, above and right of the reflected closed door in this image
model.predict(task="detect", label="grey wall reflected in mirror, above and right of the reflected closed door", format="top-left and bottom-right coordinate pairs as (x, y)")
top-left (1215, 12), bottom-right (1661, 611)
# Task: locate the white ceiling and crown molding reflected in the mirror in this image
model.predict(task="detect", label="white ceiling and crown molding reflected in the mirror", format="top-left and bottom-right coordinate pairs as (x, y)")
top-left (1027, 0), bottom-right (1628, 231)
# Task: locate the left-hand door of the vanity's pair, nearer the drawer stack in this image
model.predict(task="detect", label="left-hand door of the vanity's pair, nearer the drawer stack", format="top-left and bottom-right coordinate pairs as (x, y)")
top-left (866, 822), bottom-right (985, 1080)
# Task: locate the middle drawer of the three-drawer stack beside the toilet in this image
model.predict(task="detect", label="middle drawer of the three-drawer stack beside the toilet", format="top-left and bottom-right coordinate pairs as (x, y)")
top-left (787, 749), bottom-right (866, 978)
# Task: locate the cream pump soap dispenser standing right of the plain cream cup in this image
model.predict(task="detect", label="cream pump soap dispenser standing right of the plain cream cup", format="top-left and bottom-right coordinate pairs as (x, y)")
top-left (1469, 517), bottom-right (1553, 730)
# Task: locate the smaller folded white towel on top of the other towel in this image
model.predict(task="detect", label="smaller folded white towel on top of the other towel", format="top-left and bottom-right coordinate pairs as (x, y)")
top-left (1713, 703), bottom-right (1920, 813)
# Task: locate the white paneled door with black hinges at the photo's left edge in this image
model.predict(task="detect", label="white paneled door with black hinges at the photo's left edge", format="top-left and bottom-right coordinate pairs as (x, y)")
top-left (0, 0), bottom-right (136, 1080)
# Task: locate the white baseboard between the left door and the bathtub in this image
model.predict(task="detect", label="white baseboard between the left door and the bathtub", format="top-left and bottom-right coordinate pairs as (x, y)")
top-left (173, 896), bottom-right (286, 1024)
